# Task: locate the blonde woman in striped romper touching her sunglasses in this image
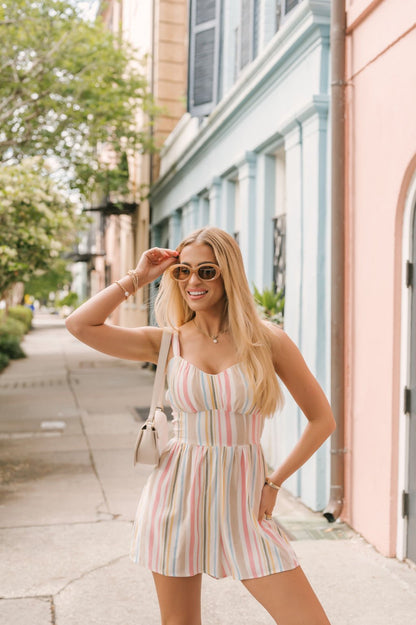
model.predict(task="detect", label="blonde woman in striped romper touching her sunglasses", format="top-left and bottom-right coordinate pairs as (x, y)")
top-left (67, 228), bottom-right (334, 625)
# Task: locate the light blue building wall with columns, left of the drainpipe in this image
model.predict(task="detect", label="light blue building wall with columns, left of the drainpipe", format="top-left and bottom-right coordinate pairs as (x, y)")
top-left (151, 0), bottom-right (330, 509)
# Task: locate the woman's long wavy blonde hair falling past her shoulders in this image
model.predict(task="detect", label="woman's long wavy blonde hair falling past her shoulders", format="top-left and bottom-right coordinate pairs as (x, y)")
top-left (155, 227), bottom-right (283, 416)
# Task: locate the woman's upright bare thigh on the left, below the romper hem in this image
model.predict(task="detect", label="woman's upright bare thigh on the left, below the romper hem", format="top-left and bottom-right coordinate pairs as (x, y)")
top-left (153, 573), bottom-right (202, 625)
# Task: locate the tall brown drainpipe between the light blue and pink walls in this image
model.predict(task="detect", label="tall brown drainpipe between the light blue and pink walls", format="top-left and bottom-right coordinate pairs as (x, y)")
top-left (323, 0), bottom-right (346, 523)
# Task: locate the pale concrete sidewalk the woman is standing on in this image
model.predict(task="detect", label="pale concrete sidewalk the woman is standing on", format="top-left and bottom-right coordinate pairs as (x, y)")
top-left (0, 315), bottom-right (416, 625)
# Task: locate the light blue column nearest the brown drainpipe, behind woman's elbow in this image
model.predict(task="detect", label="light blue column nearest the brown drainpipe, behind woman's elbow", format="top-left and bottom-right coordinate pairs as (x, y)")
top-left (299, 107), bottom-right (331, 510)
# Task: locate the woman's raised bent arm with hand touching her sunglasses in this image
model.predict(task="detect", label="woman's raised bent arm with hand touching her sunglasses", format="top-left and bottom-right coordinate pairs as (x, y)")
top-left (66, 247), bottom-right (178, 362)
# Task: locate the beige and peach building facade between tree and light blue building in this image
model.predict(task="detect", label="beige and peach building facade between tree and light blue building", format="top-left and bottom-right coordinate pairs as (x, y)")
top-left (91, 0), bottom-right (188, 327)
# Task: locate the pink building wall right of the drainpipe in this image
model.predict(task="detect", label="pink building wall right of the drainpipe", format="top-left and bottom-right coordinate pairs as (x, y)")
top-left (344, 0), bottom-right (416, 556)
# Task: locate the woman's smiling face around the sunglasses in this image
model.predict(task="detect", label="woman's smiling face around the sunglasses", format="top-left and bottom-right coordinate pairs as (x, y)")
top-left (179, 243), bottom-right (225, 312)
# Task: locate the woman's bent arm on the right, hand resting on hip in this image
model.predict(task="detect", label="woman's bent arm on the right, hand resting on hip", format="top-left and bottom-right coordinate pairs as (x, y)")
top-left (259, 327), bottom-right (335, 518)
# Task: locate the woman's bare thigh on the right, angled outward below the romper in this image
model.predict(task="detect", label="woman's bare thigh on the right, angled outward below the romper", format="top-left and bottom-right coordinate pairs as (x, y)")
top-left (243, 566), bottom-right (330, 625)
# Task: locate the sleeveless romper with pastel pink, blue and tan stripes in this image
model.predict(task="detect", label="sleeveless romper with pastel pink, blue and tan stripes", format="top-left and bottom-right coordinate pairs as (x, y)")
top-left (131, 334), bottom-right (298, 579)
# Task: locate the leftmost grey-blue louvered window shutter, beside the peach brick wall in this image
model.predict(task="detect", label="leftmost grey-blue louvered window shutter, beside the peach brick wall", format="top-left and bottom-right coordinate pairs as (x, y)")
top-left (188, 0), bottom-right (221, 117)
